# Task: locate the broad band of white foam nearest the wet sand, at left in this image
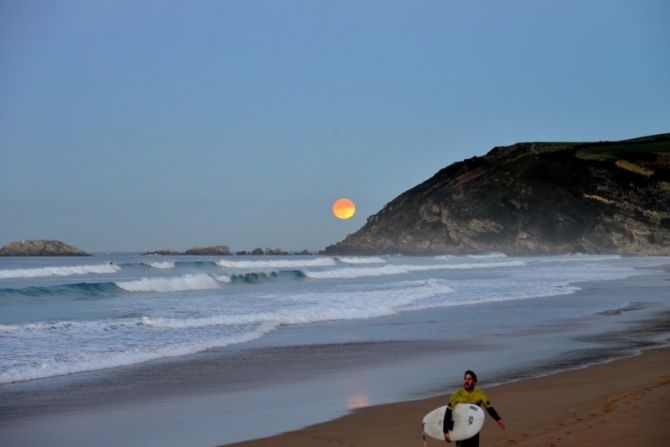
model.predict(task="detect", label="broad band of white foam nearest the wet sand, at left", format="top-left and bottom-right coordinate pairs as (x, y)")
top-left (0, 280), bottom-right (453, 383)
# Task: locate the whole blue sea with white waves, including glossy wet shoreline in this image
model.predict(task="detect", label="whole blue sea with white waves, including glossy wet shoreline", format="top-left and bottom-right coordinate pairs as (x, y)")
top-left (0, 253), bottom-right (670, 446)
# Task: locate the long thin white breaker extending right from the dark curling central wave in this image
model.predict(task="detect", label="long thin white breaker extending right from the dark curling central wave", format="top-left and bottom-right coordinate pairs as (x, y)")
top-left (305, 261), bottom-right (526, 279)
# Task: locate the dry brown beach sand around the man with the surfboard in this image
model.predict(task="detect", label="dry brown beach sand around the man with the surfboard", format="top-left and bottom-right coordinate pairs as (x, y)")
top-left (224, 348), bottom-right (670, 447)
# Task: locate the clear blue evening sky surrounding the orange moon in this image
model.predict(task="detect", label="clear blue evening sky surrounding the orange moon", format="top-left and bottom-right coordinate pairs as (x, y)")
top-left (0, 0), bottom-right (670, 252)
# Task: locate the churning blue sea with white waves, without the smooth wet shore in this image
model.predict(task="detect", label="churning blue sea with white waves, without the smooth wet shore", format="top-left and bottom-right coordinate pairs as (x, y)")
top-left (0, 253), bottom-right (670, 384)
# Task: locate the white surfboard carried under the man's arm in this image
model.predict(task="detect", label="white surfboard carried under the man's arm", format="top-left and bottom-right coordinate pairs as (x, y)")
top-left (423, 404), bottom-right (485, 441)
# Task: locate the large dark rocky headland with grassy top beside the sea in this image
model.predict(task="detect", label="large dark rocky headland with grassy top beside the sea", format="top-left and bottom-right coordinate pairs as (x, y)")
top-left (326, 134), bottom-right (670, 255)
